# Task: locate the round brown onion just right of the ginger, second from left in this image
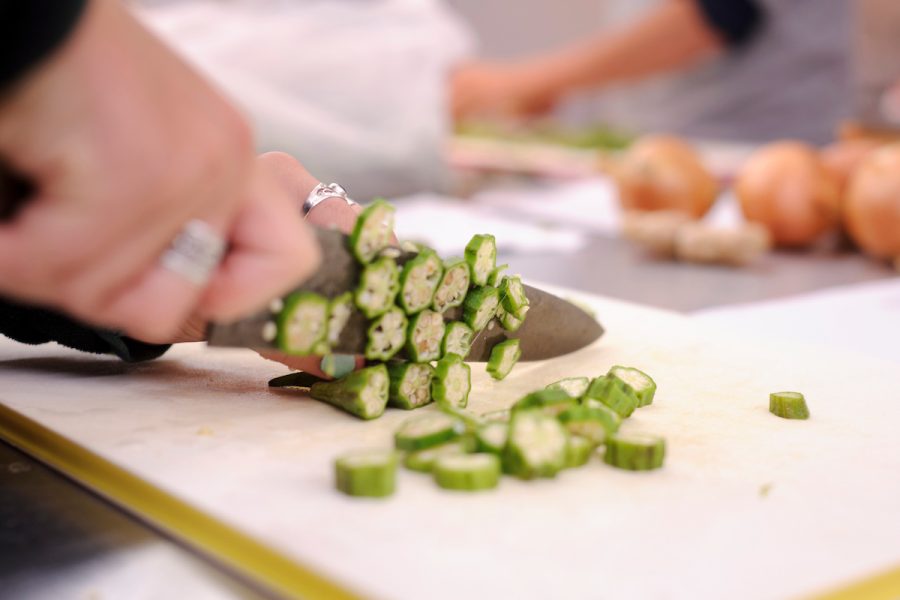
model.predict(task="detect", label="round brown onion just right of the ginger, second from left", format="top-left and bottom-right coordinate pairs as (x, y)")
top-left (735, 142), bottom-right (839, 246)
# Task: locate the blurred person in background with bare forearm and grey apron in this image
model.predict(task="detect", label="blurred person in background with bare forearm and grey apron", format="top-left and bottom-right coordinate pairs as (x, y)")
top-left (451, 0), bottom-right (853, 143)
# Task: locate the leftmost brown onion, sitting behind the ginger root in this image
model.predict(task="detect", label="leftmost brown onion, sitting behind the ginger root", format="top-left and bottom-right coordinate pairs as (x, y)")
top-left (613, 136), bottom-right (718, 218)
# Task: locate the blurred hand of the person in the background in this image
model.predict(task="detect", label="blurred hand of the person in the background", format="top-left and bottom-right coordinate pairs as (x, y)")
top-left (450, 62), bottom-right (559, 120)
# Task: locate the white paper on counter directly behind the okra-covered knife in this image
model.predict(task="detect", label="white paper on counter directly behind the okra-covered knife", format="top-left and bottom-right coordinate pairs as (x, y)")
top-left (394, 194), bottom-right (587, 256)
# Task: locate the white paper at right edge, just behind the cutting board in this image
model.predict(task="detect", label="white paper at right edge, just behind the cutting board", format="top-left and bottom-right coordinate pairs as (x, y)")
top-left (693, 278), bottom-right (900, 360)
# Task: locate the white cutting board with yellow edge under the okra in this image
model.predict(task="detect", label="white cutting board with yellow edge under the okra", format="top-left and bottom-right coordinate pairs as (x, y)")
top-left (0, 298), bottom-right (900, 600)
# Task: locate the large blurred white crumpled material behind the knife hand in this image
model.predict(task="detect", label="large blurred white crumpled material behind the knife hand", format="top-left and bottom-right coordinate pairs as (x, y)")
top-left (134, 0), bottom-right (472, 200)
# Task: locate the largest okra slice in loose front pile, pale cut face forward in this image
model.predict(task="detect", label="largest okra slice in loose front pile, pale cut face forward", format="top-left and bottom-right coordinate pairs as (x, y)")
top-left (503, 410), bottom-right (569, 479)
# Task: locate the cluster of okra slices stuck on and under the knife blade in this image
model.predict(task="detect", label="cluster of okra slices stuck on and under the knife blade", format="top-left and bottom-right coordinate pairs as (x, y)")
top-left (270, 200), bottom-right (529, 419)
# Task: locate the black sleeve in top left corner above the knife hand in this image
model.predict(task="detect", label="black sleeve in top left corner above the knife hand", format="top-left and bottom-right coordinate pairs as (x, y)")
top-left (0, 0), bottom-right (88, 89)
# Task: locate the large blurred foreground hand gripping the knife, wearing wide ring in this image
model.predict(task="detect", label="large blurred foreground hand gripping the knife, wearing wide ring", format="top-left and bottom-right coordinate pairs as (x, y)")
top-left (0, 0), bottom-right (318, 339)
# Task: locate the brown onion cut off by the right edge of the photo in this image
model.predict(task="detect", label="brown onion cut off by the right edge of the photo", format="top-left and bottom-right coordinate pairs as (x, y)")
top-left (844, 144), bottom-right (900, 258)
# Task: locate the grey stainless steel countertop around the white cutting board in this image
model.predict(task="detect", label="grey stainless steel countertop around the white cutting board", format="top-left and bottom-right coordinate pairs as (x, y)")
top-left (0, 236), bottom-right (894, 599)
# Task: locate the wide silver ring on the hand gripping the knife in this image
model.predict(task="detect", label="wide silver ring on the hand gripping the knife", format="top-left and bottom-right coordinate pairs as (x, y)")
top-left (159, 219), bottom-right (226, 287)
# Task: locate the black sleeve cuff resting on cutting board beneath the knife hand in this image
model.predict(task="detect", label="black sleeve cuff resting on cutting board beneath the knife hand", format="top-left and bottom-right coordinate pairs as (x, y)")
top-left (0, 298), bottom-right (169, 362)
